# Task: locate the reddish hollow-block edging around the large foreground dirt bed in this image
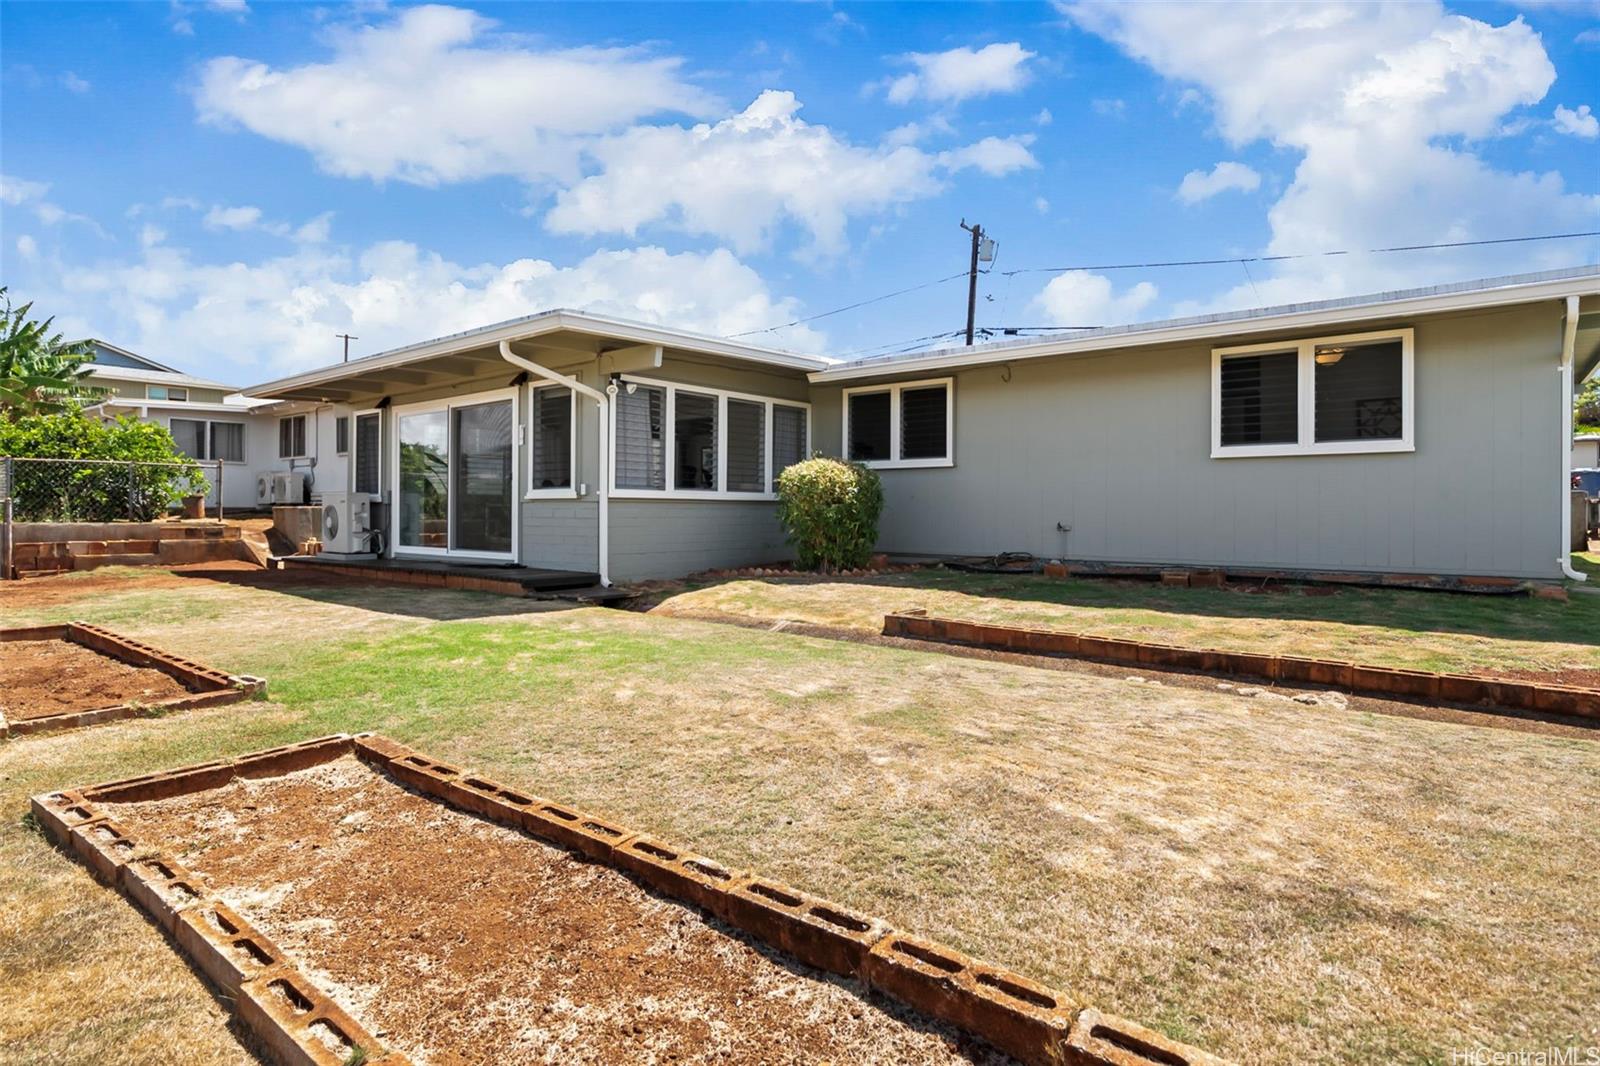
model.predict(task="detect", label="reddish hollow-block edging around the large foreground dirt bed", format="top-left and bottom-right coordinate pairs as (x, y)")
top-left (32, 733), bottom-right (1224, 1066)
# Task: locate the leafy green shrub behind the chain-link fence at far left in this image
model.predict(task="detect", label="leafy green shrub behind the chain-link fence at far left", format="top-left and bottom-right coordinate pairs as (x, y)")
top-left (0, 411), bottom-right (211, 522)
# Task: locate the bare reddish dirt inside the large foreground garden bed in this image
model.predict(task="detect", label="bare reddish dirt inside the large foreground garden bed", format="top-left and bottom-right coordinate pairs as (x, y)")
top-left (106, 757), bottom-right (1005, 1063)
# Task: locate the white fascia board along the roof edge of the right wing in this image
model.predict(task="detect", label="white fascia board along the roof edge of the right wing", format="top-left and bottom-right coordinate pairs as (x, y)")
top-left (808, 274), bottom-right (1600, 384)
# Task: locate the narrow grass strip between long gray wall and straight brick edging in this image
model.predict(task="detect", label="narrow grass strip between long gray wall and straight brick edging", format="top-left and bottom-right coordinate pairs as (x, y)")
top-left (656, 555), bottom-right (1600, 672)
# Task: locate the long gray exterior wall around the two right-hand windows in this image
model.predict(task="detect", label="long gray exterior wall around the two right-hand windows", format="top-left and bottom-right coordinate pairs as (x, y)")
top-left (811, 301), bottom-right (1565, 578)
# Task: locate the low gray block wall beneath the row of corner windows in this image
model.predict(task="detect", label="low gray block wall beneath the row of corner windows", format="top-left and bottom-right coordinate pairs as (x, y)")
top-left (611, 499), bottom-right (794, 581)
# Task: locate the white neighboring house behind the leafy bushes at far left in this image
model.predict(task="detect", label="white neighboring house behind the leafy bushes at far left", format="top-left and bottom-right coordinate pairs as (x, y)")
top-left (83, 339), bottom-right (349, 511)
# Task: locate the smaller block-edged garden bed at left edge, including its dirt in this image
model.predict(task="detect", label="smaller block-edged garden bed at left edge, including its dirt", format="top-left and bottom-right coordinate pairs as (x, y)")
top-left (0, 623), bottom-right (266, 736)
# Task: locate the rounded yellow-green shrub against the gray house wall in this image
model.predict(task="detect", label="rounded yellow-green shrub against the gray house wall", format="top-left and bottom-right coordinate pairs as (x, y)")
top-left (778, 458), bottom-right (883, 570)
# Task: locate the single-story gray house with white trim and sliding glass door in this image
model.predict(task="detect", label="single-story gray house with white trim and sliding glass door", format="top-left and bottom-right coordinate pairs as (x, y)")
top-left (245, 267), bottom-right (1600, 579)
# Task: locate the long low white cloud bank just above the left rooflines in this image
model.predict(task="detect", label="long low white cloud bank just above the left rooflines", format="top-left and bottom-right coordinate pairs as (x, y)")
top-left (13, 227), bottom-right (824, 377)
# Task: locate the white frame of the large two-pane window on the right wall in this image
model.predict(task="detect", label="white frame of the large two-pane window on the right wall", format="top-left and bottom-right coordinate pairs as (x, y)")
top-left (1211, 327), bottom-right (1416, 459)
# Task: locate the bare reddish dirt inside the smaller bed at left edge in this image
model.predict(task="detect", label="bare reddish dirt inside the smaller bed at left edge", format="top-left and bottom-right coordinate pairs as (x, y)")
top-left (0, 640), bottom-right (189, 720)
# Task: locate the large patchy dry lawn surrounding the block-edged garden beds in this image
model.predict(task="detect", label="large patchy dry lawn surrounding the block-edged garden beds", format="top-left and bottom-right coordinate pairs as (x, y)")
top-left (0, 569), bottom-right (1600, 1063)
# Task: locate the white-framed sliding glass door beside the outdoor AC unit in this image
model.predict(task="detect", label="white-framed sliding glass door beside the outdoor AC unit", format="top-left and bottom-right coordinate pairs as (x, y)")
top-left (395, 392), bottom-right (517, 559)
